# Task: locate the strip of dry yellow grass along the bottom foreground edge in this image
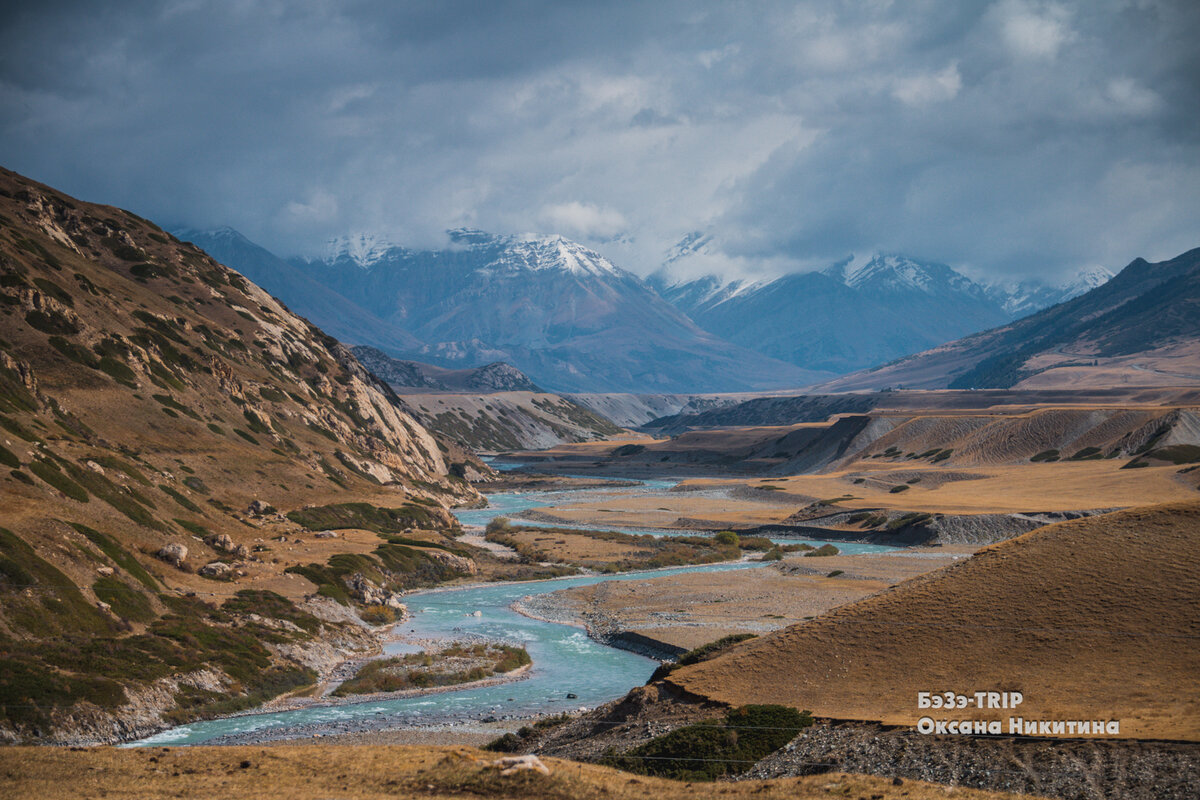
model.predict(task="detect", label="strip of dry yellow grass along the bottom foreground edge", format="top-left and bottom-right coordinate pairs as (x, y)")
top-left (0, 746), bottom-right (1028, 800)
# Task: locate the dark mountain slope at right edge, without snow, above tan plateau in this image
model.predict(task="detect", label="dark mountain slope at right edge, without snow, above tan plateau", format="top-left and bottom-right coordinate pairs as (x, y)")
top-left (820, 248), bottom-right (1200, 391)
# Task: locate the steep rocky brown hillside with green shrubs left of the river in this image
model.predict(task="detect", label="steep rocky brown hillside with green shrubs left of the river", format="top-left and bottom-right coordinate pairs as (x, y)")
top-left (0, 170), bottom-right (478, 741)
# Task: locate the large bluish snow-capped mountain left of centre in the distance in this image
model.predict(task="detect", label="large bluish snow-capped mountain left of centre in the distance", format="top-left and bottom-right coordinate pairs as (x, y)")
top-left (192, 230), bottom-right (830, 392)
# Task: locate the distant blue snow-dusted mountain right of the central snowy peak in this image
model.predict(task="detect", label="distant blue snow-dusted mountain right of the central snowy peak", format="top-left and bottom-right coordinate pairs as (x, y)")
top-left (658, 255), bottom-right (1008, 373)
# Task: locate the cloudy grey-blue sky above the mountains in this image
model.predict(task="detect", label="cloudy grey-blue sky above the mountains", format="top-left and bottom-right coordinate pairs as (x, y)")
top-left (0, 0), bottom-right (1200, 281)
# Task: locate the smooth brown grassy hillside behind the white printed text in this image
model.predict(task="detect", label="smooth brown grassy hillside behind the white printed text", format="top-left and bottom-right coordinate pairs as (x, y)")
top-left (668, 504), bottom-right (1200, 740)
